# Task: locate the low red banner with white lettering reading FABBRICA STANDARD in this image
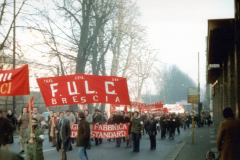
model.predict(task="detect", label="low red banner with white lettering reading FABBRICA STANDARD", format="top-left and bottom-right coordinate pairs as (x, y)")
top-left (71, 123), bottom-right (129, 138)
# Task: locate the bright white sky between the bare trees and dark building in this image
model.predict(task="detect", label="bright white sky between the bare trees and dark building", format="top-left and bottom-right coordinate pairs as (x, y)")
top-left (137, 0), bottom-right (234, 88)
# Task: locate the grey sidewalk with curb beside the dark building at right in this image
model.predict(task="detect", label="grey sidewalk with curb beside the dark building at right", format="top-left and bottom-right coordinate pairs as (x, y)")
top-left (167, 125), bottom-right (218, 160)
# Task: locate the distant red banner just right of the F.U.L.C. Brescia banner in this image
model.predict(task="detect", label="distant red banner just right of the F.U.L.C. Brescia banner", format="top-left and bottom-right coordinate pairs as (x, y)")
top-left (131, 101), bottom-right (163, 110)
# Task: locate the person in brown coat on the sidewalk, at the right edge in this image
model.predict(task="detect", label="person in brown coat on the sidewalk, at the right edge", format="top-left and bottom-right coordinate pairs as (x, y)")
top-left (217, 108), bottom-right (240, 160)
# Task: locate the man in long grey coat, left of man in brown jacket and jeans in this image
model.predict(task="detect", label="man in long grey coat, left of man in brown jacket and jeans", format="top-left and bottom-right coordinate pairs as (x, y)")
top-left (55, 112), bottom-right (72, 160)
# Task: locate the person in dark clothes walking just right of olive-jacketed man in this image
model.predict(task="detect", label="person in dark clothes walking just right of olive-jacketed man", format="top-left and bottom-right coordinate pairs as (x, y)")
top-left (146, 114), bottom-right (160, 149)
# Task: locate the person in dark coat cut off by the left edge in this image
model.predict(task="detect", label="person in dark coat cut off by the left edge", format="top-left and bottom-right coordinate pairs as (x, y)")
top-left (0, 110), bottom-right (12, 150)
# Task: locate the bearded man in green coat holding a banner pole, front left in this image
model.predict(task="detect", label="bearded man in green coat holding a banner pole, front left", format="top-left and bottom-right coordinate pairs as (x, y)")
top-left (23, 118), bottom-right (44, 160)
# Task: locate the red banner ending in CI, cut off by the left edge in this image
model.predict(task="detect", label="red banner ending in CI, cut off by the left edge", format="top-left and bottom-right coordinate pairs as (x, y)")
top-left (0, 65), bottom-right (30, 96)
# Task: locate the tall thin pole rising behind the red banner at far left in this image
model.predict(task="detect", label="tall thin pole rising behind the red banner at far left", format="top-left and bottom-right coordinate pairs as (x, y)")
top-left (13, 0), bottom-right (16, 114)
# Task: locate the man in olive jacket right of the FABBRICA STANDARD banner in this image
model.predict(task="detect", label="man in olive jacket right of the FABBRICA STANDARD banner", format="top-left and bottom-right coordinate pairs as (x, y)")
top-left (130, 111), bottom-right (143, 152)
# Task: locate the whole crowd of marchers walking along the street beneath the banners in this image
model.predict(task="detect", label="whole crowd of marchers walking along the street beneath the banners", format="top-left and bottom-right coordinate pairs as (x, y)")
top-left (0, 107), bottom-right (212, 160)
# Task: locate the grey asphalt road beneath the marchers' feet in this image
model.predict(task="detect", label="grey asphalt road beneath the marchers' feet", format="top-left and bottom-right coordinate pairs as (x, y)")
top-left (9, 128), bottom-right (191, 160)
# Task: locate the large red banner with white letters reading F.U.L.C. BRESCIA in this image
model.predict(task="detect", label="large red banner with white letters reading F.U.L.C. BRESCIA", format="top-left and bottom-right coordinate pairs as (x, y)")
top-left (37, 74), bottom-right (130, 107)
